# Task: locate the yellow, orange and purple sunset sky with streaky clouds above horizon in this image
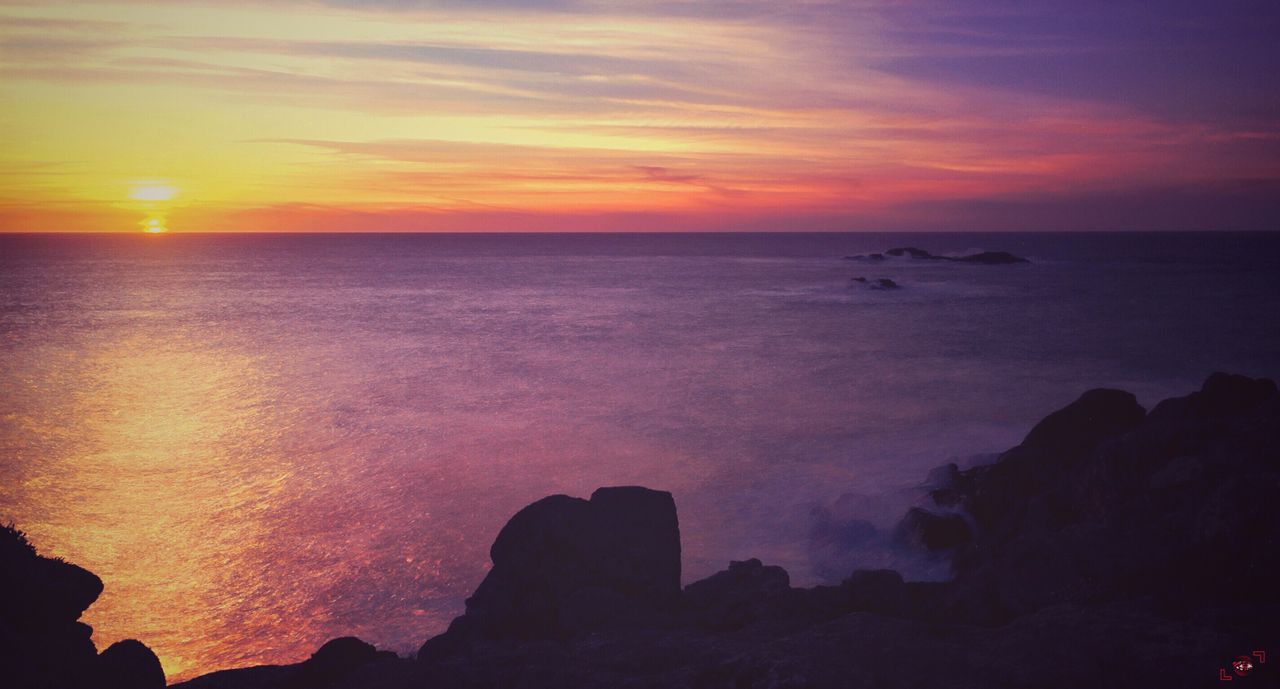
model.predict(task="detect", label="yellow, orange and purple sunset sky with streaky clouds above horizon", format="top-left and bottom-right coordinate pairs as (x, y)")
top-left (0, 0), bottom-right (1280, 232)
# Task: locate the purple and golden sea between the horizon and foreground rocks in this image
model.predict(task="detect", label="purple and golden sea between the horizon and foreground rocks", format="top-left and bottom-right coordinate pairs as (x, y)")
top-left (0, 234), bottom-right (1280, 677)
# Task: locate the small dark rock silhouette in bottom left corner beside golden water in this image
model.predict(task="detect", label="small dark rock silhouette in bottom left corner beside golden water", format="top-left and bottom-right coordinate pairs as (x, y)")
top-left (0, 525), bottom-right (165, 689)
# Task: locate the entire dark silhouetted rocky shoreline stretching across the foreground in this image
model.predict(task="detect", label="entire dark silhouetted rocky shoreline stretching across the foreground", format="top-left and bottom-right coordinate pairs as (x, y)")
top-left (0, 374), bottom-right (1280, 689)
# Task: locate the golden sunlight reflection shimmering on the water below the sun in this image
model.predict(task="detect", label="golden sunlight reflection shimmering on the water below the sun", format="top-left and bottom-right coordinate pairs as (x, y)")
top-left (8, 334), bottom-right (292, 680)
